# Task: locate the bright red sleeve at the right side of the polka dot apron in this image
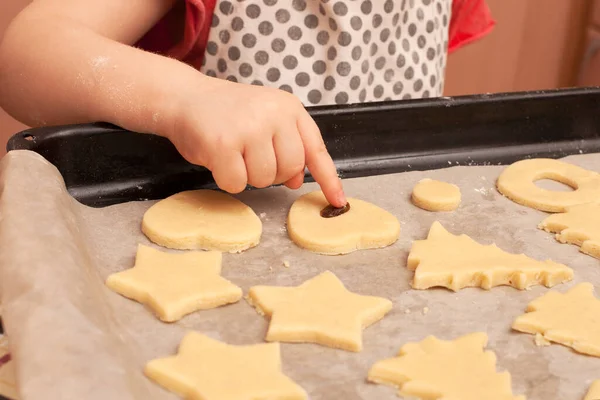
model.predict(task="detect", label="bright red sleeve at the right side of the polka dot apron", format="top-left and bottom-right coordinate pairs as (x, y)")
top-left (448, 0), bottom-right (496, 53)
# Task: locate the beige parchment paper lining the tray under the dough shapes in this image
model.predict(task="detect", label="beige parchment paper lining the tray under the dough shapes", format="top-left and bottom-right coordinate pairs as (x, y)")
top-left (0, 152), bottom-right (600, 400)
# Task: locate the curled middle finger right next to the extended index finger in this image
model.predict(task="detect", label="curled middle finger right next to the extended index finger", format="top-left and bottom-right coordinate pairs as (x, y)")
top-left (273, 123), bottom-right (306, 183)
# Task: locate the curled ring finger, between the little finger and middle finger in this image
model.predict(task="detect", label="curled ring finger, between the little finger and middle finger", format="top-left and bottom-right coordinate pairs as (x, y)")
top-left (244, 141), bottom-right (277, 188)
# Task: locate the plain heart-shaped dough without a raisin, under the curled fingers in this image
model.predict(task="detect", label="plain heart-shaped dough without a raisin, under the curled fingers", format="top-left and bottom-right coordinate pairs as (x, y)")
top-left (142, 190), bottom-right (262, 253)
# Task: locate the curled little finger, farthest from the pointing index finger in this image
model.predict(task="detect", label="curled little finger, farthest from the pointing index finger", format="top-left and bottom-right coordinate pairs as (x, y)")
top-left (211, 150), bottom-right (248, 193)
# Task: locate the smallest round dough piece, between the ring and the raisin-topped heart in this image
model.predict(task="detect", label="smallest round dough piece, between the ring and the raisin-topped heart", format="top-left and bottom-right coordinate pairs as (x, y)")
top-left (412, 179), bottom-right (460, 211)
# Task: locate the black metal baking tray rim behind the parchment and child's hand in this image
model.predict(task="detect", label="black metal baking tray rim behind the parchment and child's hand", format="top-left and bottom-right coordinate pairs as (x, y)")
top-left (7, 88), bottom-right (600, 207)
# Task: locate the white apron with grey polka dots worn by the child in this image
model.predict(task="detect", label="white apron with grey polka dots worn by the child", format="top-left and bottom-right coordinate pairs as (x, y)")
top-left (201, 0), bottom-right (451, 105)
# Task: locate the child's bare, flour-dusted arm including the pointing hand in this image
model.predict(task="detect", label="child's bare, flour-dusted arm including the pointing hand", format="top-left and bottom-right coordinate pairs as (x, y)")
top-left (0, 0), bottom-right (346, 206)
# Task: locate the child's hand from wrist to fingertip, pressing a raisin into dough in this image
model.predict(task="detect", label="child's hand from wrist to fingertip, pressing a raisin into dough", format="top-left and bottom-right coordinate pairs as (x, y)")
top-left (168, 76), bottom-right (346, 207)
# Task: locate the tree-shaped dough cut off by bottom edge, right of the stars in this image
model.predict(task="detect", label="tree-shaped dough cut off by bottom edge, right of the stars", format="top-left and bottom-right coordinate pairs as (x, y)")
top-left (368, 333), bottom-right (525, 400)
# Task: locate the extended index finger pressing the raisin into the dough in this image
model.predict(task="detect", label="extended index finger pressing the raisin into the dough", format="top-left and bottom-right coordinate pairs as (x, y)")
top-left (298, 111), bottom-right (347, 207)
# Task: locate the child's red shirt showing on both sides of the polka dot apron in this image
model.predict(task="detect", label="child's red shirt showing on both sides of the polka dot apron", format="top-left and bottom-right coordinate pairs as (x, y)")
top-left (137, 0), bottom-right (495, 69)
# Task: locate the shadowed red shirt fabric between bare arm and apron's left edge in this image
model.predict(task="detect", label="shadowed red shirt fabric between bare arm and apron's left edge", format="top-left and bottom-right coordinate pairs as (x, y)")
top-left (137, 0), bottom-right (217, 69)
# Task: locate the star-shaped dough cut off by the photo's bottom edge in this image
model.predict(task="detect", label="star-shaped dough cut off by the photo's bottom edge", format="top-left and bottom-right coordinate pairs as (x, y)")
top-left (144, 332), bottom-right (307, 400)
